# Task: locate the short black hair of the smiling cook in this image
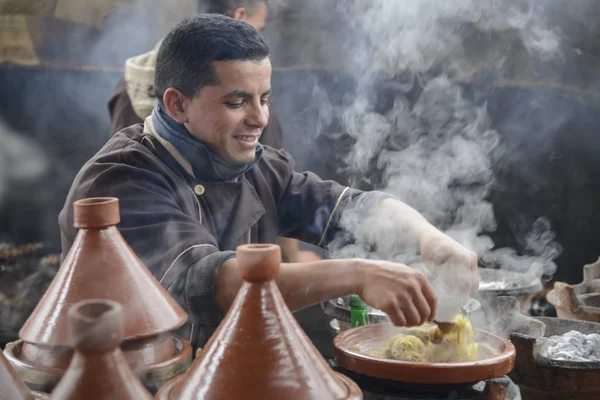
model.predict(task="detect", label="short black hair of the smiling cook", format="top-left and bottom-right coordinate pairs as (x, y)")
top-left (154, 14), bottom-right (269, 106)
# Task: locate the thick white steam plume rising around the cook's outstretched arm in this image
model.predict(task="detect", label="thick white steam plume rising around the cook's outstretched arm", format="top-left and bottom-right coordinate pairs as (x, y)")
top-left (290, 0), bottom-right (562, 278)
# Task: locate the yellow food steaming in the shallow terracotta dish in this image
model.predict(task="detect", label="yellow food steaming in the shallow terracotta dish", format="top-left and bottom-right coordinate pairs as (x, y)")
top-left (365, 314), bottom-right (479, 363)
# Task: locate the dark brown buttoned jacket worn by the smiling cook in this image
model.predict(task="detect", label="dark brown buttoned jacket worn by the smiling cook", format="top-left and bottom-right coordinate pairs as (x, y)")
top-left (59, 124), bottom-right (360, 346)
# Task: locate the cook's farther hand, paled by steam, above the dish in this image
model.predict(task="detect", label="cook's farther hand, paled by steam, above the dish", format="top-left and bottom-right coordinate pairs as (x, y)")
top-left (419, 229), bottom-right (479, 297)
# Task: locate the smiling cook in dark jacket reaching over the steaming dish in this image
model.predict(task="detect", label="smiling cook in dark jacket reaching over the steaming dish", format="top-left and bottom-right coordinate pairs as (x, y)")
top-left (59, 15), bottom-right (478, 346)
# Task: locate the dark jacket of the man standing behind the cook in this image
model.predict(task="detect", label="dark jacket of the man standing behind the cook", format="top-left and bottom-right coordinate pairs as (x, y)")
top-left (108, 78), bottom-right (283, 150)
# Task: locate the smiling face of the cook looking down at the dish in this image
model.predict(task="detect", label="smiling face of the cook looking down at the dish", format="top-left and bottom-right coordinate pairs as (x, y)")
top-left (180, 57), bottom-right (271, 165)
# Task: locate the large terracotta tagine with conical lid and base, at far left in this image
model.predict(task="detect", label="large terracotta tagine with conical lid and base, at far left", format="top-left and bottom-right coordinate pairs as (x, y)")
top-left (5, 198), bottom-right (192, 392)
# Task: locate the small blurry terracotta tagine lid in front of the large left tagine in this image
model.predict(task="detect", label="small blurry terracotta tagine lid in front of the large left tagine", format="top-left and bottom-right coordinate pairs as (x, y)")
top-left (51, 299), bottom-right (152, 400)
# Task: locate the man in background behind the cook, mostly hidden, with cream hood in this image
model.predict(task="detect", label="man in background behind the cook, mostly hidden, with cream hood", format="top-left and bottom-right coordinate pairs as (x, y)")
top-left (108, 0), bottom-right (320, 262)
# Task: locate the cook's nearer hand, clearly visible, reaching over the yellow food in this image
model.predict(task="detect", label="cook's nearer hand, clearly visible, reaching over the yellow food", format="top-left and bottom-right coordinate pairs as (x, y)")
top-left (358, 260), bottom-right (437, 326)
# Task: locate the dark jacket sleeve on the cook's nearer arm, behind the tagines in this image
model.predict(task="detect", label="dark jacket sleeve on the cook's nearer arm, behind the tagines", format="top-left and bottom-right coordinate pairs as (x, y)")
top-left (61, 155), bottom-right (235, 346)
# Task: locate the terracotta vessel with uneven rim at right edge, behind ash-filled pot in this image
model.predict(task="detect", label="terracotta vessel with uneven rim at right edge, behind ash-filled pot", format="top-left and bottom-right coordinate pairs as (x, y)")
top-left (546, 258), bottom-right (600, 322)
